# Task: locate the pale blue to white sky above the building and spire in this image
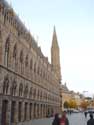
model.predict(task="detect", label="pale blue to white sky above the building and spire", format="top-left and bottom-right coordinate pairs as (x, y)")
top-left (7, 0), bottom-right (94, 94)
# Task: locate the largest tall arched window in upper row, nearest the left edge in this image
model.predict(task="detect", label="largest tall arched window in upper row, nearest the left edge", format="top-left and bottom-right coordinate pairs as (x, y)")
top-left (4, 35), bottom-right (10, 67)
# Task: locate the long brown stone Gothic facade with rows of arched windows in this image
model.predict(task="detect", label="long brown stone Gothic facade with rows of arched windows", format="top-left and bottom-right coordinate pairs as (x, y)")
top-left (0, 0), bottom-right (60, 125)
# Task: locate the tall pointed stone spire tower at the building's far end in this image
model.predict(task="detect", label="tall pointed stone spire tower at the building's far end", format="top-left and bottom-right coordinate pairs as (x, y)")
top-left (51, 26), bottom-right (61, 82)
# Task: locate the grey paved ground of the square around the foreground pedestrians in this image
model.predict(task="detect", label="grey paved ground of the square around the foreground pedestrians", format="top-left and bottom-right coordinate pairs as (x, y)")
top-left (19, 113), bottom-right (89, 125)
